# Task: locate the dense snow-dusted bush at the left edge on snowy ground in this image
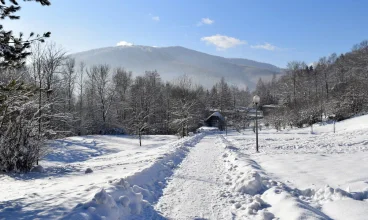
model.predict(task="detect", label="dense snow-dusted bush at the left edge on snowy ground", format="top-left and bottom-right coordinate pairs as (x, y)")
top-left (0, 80), bottom-right (49, 172)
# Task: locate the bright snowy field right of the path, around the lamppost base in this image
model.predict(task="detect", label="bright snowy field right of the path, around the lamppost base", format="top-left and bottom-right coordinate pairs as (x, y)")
top-left (227, 116), bottom-right (368, 219)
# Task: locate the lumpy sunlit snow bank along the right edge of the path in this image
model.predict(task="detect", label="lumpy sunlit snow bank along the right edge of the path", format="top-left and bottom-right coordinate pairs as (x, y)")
top-left (220, 136), bottom-right (276, 217)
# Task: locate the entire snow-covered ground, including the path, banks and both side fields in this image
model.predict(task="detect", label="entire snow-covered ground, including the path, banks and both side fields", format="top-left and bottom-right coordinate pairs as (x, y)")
top-left (0, 116), bottom-right (368, 219)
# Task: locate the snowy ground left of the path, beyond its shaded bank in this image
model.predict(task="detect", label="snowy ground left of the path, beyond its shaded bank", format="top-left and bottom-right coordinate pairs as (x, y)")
top-left (0, 136), bottom-right (181, 219)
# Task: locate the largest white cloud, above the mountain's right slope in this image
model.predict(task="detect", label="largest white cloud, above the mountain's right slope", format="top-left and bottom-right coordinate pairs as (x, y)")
top-left (201, 34), bottom-right (247, 50)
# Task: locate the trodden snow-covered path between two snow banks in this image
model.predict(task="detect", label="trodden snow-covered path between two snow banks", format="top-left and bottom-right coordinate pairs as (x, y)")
top-left (156, 135), bottom-right (232, 219)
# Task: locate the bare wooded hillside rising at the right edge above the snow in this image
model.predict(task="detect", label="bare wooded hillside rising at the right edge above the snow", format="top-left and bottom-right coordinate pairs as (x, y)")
top-left (255, 41), bottom-right (368, 128)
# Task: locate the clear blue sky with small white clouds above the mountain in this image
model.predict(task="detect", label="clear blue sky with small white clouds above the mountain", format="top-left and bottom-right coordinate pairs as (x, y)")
top-left (2, 0), bottom-right (368, 67)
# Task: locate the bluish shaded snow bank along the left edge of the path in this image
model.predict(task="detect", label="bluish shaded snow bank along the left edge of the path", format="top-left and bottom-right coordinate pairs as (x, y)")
top-left (63, 134), bottom-right (203, 220)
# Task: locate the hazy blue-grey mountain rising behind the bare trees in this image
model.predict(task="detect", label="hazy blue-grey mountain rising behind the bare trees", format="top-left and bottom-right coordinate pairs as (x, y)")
top-left (70, 46), bottom-right (282, 89)
